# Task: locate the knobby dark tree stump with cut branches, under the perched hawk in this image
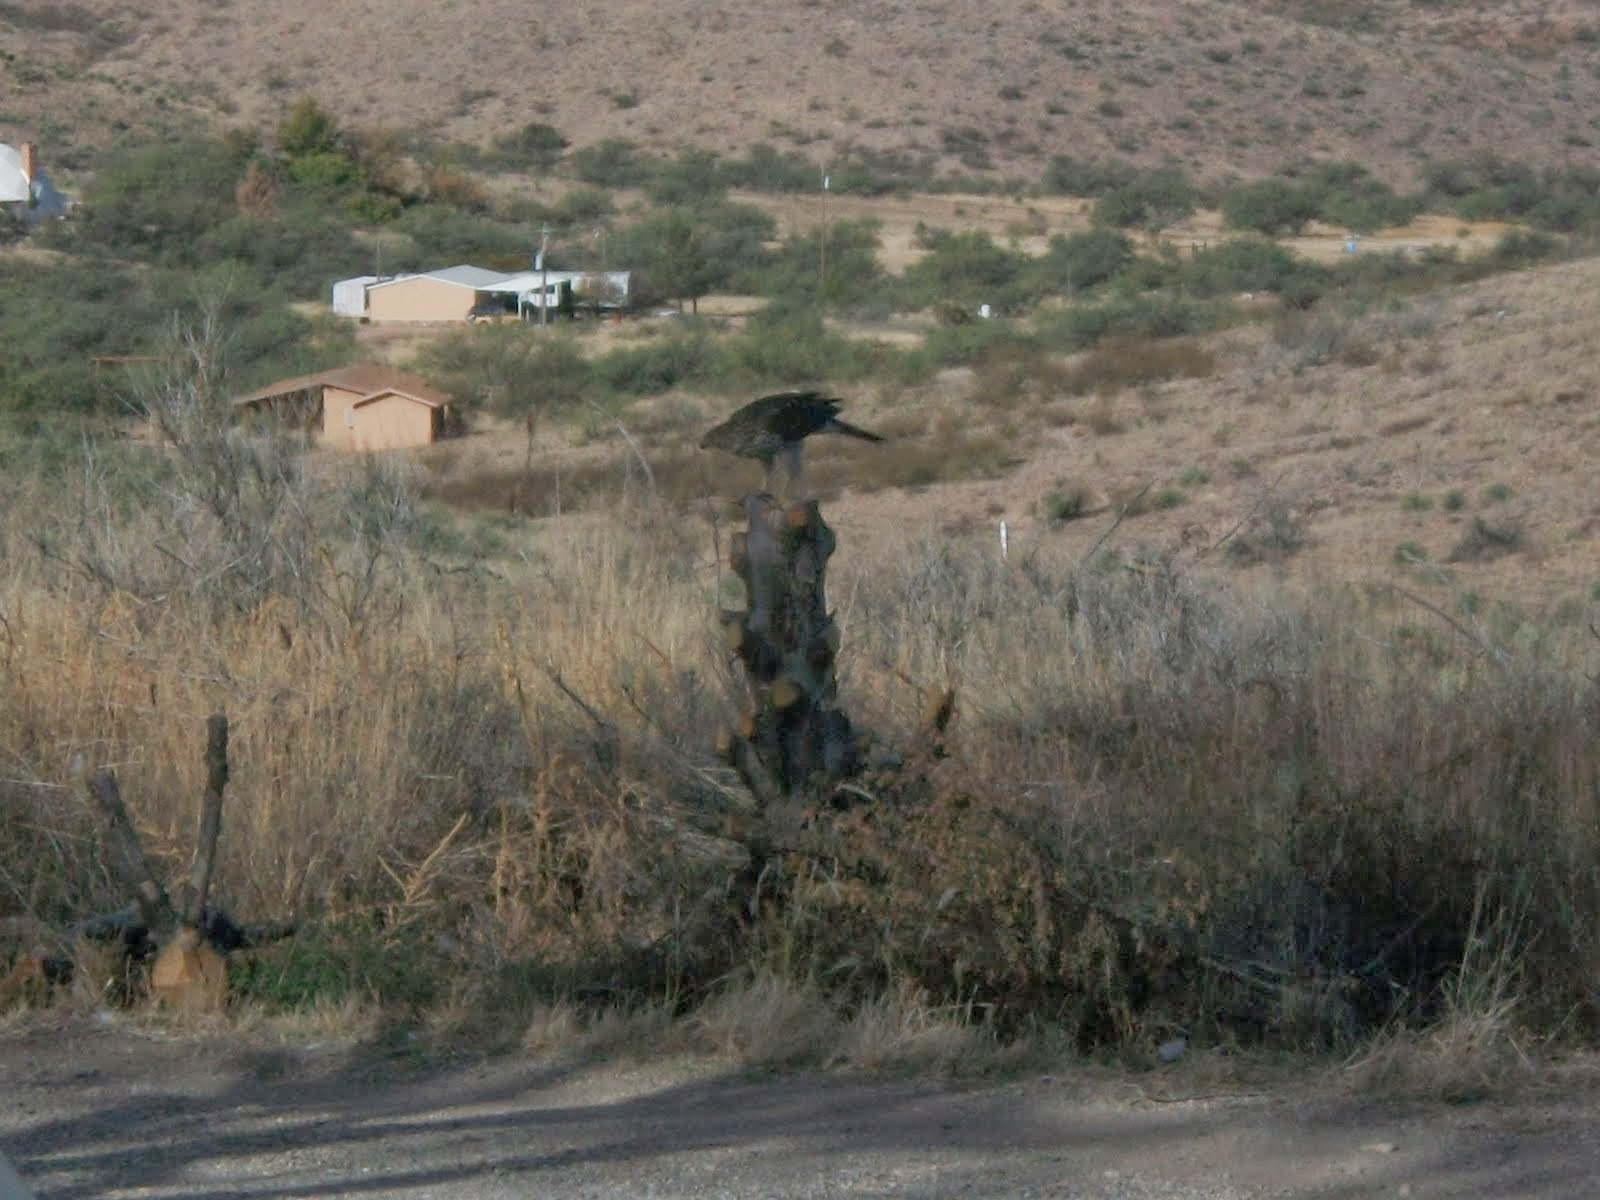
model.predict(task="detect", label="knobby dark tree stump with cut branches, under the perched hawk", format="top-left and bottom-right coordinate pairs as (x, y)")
top-left (720, 493), bottom-right (861, 803)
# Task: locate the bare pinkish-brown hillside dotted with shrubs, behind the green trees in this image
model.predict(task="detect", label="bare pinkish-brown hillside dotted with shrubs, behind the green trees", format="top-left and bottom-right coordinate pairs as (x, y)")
top-left (0, 0), bottom-right (1600, 184)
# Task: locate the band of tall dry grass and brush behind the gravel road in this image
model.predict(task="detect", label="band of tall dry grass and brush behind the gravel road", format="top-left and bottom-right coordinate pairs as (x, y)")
top-left (0, 385), bottom-right (1600, 1046)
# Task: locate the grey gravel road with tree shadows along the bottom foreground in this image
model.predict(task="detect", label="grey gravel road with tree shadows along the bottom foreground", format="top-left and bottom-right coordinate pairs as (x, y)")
top-left (0, 1026), bottom-right (1600, 1200)
